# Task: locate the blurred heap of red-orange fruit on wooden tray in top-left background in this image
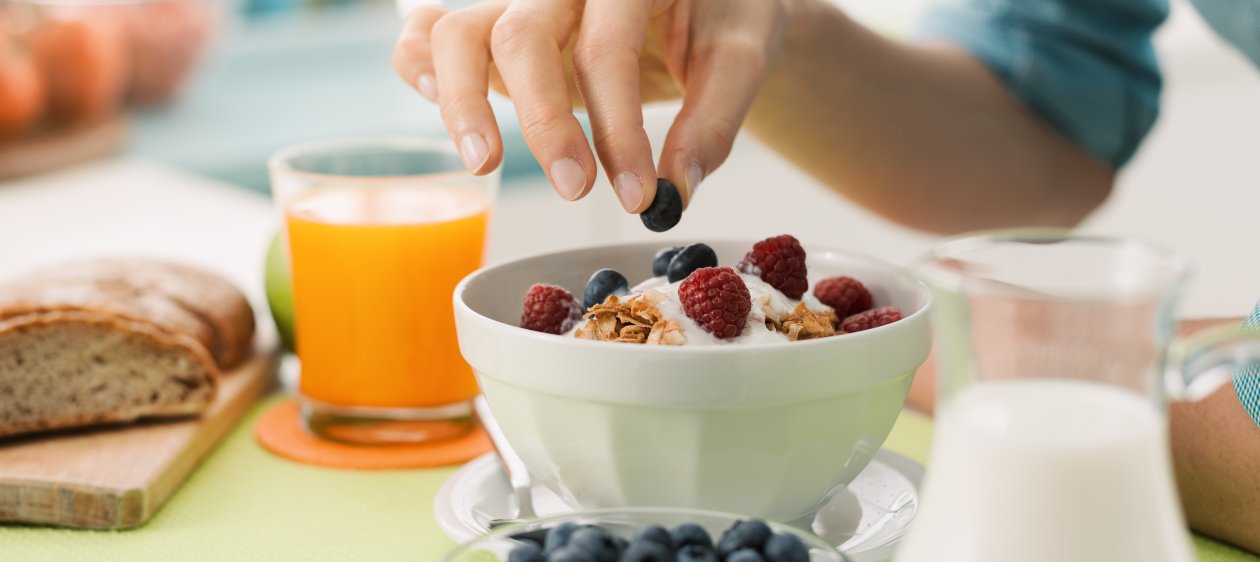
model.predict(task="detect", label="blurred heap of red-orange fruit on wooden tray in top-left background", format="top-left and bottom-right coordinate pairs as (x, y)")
top-left (0, 0), bottom-right (215, 179)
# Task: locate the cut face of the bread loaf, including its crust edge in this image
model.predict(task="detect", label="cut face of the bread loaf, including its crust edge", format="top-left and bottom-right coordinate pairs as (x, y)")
top-left (0, 311), bottom-right (219, 436)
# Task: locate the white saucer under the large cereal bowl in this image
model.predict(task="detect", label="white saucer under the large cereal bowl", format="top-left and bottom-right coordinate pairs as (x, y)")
top-left (433, 450), bottom-right (924, 562)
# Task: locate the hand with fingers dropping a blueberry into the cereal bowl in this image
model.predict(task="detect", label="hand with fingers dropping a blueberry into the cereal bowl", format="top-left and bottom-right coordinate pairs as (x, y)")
top-left (393, 0), bottom-right (788, 213)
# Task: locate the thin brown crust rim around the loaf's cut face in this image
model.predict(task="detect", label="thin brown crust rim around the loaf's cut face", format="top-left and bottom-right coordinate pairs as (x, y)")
top-left (0, 310), bottom-right (221, 436)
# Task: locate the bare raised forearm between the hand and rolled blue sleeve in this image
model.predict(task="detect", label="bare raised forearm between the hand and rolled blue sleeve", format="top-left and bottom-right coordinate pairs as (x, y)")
top-left (747, 0), bottom-right (1113, 232)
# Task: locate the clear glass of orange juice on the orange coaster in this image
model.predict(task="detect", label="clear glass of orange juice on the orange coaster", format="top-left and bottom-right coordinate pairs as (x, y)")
top-left (270, 137), bottom-right (499, 444)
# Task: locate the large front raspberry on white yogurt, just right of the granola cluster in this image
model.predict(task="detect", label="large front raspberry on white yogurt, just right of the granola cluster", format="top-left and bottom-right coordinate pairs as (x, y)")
top-left (678, 267), bottom-right (752, 339)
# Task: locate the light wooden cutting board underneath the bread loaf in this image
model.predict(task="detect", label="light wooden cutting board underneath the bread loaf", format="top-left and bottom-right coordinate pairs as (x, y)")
top-left (0, 352), bottom-right (276, 529)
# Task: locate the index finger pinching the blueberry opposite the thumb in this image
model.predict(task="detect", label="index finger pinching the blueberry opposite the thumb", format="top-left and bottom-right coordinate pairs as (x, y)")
top-left (573, 0), bottom-right (656, 213)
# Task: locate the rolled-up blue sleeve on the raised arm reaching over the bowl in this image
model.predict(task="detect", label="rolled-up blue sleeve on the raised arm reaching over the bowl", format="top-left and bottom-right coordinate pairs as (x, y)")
top-left (916, 0), bottom-right (1168, 168)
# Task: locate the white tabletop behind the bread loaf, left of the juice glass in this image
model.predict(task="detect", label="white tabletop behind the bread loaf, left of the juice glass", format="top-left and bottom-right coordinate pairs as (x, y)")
top-left (0, 159), bottom-right (276, 304)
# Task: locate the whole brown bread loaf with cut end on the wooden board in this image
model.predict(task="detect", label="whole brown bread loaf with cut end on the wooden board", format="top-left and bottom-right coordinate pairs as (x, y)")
top-left (0, 260), bottom-right (255, 436)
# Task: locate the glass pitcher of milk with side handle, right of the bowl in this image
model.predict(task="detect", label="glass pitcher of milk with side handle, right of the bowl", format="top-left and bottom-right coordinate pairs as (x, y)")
top-left (895, 231), bottom-right (1260, 562)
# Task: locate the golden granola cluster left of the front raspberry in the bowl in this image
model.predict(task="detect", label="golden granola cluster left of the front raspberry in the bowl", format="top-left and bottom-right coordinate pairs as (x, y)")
top-left (573, 292), bottom-right (687, 345)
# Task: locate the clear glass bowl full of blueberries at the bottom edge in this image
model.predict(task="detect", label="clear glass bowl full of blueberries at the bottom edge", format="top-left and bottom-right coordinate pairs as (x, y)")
top-left (445, 508), bottom-right (848, 562)
